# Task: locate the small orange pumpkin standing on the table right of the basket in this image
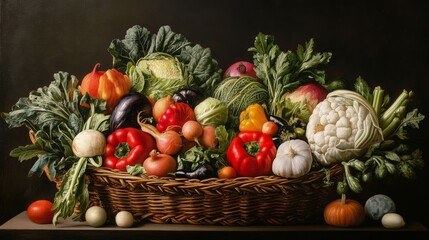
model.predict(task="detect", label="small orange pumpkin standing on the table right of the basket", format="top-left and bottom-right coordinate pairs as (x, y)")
top-left (323, 194), bottom-right (365, 227)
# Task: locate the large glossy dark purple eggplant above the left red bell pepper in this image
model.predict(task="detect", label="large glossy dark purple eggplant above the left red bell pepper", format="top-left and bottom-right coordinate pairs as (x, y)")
top-left (110, 93), bottom-right (152, 132)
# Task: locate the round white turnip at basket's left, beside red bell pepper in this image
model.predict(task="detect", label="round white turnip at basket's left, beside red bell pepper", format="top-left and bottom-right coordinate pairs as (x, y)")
top-left (72, 129), bottom-right (106, 157)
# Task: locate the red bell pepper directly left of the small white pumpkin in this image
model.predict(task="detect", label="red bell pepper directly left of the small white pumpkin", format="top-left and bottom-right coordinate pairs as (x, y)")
top-left (226, 131), bottom-right (277, 177)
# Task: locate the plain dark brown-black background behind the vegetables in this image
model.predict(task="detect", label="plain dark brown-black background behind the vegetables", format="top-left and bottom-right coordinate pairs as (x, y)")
top-left (0, 0), bottom-right (429, 231)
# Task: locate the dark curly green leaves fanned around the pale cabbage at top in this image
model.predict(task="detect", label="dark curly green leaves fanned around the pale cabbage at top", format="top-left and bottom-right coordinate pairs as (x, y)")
top-left (108, 25), bottom-right (222, 96)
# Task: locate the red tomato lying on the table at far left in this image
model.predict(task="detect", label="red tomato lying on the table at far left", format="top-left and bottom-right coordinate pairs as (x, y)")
top-left (27, 200), bottom-right (55, 224)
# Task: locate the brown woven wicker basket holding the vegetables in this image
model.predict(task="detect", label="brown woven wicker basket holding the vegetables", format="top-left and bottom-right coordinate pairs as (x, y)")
top-left (88, 165), bottom-right (343, 225)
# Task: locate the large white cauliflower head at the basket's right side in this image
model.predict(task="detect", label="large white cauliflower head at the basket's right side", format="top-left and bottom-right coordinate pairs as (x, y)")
top-left (306, 90), bottom-right (383, 165)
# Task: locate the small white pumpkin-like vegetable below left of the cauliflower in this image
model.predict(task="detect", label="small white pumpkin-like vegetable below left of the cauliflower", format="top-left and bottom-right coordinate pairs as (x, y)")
top-left (272, 139), bottom-right (313, 178)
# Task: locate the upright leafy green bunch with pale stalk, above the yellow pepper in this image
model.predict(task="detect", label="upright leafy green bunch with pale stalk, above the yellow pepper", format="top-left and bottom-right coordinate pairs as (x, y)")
top-left (249, 33), bottom-right (332, 119)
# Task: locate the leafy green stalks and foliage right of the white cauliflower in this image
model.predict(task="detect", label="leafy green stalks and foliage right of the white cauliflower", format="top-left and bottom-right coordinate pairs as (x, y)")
top-left (337, 77), bottom-right (425, 193)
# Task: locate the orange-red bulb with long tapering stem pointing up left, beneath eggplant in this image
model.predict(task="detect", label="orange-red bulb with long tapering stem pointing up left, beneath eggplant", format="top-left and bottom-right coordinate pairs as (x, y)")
top-left (137, 114), bottom-right (183, 155)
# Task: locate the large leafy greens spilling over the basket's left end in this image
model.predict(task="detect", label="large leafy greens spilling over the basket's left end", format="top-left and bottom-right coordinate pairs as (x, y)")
top-left (1, 72), bottom-right (109, 224)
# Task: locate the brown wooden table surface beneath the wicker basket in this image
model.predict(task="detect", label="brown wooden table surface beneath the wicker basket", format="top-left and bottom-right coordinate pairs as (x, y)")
top-left (0, 212), bottom-right (429, 240)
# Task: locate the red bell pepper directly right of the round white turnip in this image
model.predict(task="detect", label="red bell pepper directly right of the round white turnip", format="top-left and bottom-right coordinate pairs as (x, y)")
top-left (104, 128), bottom-right (156, 171)
